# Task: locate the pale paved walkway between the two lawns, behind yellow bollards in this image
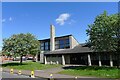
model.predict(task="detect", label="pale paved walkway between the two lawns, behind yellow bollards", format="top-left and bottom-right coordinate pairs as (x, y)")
top-left (3, 67), bottom-right (93, 78)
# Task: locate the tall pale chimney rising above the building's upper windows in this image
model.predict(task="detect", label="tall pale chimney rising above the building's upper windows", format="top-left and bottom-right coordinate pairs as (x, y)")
top-left (50, 25), bottom-right (55, 51)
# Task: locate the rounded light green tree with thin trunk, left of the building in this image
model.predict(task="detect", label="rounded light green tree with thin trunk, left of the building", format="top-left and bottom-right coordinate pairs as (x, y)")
top-left (3, 33), bottom-right (40, 64)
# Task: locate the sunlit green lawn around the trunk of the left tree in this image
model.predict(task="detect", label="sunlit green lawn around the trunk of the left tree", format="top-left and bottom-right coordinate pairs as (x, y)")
top-left (2, 61), bottom-right (61, 70)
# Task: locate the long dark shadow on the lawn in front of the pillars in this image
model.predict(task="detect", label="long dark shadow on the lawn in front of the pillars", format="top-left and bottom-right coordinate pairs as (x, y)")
top-left (63, 66), bottom-right (117, 70)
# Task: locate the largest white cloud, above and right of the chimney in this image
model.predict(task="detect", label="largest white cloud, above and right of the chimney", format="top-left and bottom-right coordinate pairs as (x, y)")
top-left (56, 13), bottom-right (70, 25)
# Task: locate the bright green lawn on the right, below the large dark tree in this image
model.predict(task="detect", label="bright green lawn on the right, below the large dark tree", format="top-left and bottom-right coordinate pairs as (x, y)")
top-left (59, 66), bottom-right (120, 78)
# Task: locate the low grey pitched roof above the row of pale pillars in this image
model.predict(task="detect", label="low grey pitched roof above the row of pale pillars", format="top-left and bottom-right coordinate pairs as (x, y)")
top-left (45, 45), bottom-right (93, 54)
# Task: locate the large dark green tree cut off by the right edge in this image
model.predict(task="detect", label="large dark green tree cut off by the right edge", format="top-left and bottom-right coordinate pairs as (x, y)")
top-left (86, 11), bottom-right (120, 66)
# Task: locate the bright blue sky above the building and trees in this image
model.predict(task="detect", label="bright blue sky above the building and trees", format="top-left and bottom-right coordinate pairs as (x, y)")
top-left (2, 2), bottom-right (118, 49)
